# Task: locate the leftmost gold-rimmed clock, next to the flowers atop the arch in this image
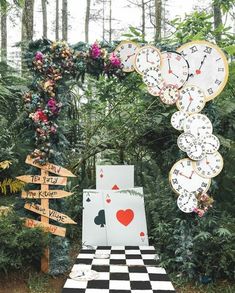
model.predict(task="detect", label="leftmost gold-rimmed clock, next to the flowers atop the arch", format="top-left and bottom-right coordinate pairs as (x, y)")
top-left (114, 41), bottom-right (139, 72)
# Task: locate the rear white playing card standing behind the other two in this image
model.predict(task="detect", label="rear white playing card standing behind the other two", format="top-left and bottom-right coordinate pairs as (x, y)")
top-left (96, 165), bottom-right (134, 190)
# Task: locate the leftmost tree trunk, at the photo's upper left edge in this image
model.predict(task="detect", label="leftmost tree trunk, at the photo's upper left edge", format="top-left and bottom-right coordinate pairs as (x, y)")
top-left (0, 0), bottom-right (7, 62)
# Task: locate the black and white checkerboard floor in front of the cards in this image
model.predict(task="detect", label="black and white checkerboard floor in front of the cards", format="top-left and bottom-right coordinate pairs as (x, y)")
top-left (62, 246), bottom-right (175, 293)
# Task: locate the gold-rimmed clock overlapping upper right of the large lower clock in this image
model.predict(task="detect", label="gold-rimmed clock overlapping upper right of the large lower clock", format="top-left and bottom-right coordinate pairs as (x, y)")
top-left (194, 152), bottom-right (223, 178)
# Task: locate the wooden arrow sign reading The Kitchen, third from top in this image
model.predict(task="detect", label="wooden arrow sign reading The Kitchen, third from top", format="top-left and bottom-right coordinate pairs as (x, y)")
top-left (21, 190), bottom-right (73, 199)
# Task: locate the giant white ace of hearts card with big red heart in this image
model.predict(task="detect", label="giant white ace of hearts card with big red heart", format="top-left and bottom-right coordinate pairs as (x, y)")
top-left (104, 187), bottom-right (148, 246)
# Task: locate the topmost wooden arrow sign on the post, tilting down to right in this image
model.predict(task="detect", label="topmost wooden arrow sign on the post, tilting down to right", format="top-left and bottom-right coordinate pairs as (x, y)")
top-left (25, 156), bottom-right (76, 177)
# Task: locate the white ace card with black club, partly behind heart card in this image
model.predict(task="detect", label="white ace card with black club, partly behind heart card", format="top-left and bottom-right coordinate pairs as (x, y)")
top-left (82, 189), bottom-right (108, 246)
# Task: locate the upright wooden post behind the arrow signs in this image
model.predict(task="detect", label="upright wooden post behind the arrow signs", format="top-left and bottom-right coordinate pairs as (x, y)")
top-left (41, 170), bottom-right (49, 273)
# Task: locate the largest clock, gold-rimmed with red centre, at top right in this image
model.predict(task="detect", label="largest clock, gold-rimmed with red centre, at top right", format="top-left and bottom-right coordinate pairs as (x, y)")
top-left (177, 41), bottom-right (229, 101)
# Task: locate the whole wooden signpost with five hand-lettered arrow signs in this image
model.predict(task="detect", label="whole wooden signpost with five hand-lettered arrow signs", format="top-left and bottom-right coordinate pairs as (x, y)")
top-left (16, 156), bottom-right (76, 273)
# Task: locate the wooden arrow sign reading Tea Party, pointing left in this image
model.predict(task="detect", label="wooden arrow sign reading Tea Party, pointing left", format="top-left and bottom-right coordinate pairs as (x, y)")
top-left (16, 175), bottom-right (67, 185)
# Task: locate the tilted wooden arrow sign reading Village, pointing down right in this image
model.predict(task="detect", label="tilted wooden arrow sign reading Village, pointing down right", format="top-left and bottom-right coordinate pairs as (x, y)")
top-left (24, 203), bottom-right (77, 224)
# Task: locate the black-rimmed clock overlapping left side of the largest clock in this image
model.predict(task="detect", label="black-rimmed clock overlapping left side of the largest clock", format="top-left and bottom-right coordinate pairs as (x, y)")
top-left (161, 52), bottom-right (189, 88)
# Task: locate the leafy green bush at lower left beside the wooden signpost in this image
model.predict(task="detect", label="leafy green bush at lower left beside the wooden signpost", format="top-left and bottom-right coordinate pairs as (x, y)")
top-left (0, 212), bottom-right (48, 273)
